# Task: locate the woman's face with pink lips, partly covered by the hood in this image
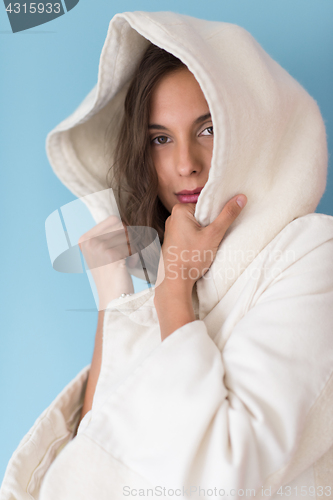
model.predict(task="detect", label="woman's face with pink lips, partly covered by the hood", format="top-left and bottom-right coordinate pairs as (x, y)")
top-left (149, 68), bottom-right (213, 212)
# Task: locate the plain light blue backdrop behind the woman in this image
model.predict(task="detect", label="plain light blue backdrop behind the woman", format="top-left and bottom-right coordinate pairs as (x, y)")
top-left (0, 0), bottom-right (333, 481)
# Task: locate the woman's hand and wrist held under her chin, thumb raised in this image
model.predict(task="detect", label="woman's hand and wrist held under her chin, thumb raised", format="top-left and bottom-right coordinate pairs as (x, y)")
top-left (154, 195), bottom-right (247, 340)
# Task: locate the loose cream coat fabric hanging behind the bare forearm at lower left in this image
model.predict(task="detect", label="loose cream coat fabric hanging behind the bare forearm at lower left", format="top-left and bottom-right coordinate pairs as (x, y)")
top-left (0, 365), bottom-right (90, 500)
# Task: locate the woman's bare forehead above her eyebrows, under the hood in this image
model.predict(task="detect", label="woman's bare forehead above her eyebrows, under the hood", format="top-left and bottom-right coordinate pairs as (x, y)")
top-left (150, 68), bottom-right (209, 119)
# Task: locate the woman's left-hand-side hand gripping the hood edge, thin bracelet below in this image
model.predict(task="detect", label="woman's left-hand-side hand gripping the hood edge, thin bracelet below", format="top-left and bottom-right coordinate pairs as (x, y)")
top-left (78, 215), bottom-right (138, 311)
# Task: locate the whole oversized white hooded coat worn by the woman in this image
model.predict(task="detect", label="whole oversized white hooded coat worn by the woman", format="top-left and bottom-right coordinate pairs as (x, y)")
top-left (0, 12), bottom-right (333, 500)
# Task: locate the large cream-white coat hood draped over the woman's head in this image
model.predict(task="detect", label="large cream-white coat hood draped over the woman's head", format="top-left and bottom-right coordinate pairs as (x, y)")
top-left (46, 12), bottom-right (328, 318)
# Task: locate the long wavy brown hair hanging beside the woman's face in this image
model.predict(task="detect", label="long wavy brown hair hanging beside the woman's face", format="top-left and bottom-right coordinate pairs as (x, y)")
top-left (108, 44), bottom-right (186, 244)
